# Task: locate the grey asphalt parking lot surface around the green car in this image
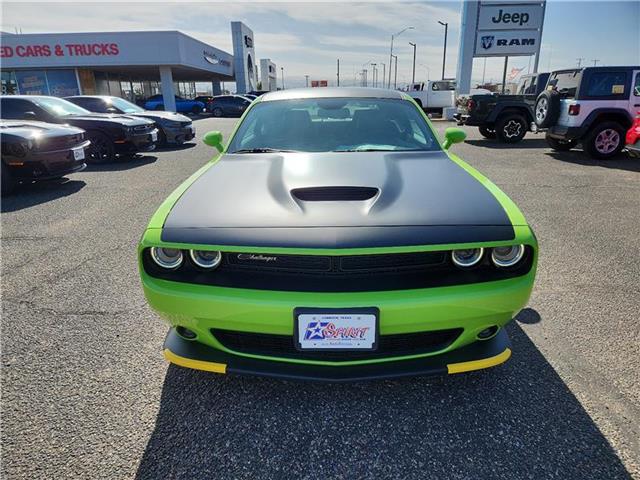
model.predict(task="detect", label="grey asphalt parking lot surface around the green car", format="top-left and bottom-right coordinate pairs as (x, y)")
top-left (1, 119), bottom-right (640, 479)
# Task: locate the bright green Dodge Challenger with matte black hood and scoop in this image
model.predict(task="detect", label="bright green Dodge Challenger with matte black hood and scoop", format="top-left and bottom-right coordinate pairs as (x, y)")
top-left (138, 88), bottom-right (538, 381)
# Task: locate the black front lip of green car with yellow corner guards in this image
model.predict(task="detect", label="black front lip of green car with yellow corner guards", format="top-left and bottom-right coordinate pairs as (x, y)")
top-left (164, 328), bottom-right (511, 382)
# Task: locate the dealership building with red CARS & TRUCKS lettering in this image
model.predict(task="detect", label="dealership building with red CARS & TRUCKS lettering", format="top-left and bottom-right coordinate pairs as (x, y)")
top-left (0, 22), bottom-right (276, 110)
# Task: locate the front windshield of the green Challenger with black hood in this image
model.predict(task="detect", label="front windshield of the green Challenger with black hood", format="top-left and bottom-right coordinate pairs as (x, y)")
top-left (227, 98), bottom-right (440, 153)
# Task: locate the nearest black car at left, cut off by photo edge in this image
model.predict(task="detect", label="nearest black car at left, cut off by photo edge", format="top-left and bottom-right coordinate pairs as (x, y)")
top-left (0, 120), bottom-right (89, 195)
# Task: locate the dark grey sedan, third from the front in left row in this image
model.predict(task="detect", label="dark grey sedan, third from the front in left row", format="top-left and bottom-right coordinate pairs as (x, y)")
top-left (66, 95), bottom-right (196, 145)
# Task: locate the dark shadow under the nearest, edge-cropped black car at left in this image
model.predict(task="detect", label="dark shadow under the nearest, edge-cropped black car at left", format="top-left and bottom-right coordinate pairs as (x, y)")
top-left (0, 178), bottom-right (86, 213)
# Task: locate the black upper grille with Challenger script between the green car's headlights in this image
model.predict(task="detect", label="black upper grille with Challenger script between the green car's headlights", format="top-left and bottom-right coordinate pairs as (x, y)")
top-left (143, 247), bottom-right (533, 292)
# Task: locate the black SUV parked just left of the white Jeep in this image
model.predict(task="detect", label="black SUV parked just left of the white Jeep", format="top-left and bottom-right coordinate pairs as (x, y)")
top-left (454, 73), bottom-right (549, 143)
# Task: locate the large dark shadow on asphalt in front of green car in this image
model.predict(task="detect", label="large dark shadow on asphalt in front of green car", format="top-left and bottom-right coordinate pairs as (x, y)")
top-left (136, 309), bottom-right (629, 480)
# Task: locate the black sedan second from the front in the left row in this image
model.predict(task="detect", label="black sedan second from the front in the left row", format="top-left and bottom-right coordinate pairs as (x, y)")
top-left (0, 95), bottom-right (158, 163)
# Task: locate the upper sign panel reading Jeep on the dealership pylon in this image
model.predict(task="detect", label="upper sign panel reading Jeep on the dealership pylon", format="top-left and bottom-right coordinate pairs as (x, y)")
top-left (478, 3), bottom-right (544, 30)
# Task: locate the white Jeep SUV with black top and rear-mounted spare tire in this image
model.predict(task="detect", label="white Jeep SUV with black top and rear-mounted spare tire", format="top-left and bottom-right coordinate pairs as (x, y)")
top-left (535, 66), bottom-right (640, 159)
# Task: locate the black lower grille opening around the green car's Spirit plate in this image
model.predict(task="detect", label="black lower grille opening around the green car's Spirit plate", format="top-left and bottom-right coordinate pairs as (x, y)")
top-left (211, 328), bottom-right (462, 362)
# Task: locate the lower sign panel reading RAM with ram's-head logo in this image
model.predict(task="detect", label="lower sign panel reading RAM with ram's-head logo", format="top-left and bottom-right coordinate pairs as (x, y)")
top-left (475, 30), bottom-right (540, 57)
